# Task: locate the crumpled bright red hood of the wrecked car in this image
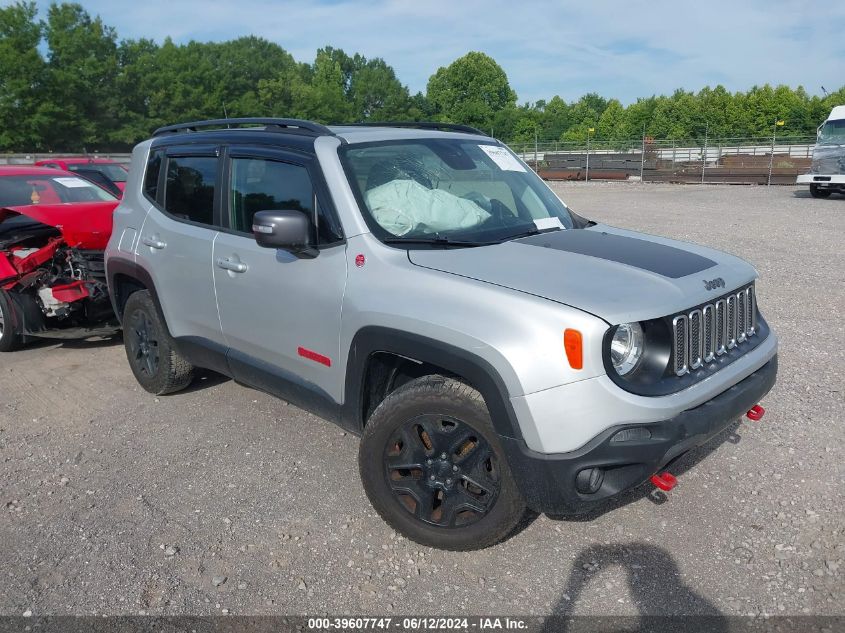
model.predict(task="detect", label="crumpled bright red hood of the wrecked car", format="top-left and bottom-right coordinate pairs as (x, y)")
top-left (0, 200), bottom-right (119, 251)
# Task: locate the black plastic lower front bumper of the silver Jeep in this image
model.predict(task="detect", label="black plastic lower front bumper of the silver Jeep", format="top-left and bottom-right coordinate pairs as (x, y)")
top-left (501, 356), bottom-right (777, 514)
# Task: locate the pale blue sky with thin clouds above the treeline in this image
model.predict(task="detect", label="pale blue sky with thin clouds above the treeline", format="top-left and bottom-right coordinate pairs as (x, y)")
top-left (23, 0), bottom-right (845, 104)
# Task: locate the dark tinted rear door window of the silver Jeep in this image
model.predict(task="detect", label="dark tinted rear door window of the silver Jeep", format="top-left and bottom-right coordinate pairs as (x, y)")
top-left (164, 156), bottom-right (217, 224)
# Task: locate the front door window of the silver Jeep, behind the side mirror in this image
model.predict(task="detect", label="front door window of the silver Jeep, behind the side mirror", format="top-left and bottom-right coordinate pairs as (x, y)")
top-left (229, 158), bottom-right (341, 244)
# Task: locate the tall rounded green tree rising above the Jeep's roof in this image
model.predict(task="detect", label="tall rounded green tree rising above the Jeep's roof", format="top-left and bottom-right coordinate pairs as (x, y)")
top-left (427, 52), bottom-right (516, 129)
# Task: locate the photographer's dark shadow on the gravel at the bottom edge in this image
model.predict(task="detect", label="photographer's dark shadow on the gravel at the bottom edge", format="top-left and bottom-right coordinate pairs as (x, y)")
top-left (543, 542), bottom-right (729, 633)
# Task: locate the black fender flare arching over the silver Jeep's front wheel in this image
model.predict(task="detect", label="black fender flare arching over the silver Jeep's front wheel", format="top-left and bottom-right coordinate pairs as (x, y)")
top-left (343, 326), bottom-right (522, 440)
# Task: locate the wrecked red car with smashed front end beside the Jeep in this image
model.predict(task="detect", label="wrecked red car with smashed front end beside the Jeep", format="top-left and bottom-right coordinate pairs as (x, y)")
top-left (0, 166), bottom-right (118, 352)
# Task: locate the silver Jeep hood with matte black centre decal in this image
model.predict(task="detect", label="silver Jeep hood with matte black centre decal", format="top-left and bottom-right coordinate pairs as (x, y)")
top-left (408, 225), bottom-right (757, 325)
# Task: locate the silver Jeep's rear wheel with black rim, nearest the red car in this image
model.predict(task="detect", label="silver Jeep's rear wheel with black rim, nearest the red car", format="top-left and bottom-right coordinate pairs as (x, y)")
top-left (123, 290), bottom-right (194, 396)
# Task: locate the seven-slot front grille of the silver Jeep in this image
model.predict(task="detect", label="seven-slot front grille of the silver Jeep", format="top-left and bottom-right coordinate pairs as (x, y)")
top-left (672, 286), bottom-right (757, 376)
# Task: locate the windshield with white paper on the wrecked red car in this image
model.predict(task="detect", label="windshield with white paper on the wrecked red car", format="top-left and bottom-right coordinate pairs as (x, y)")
top-left (0, 175), bottom-right (117, 207)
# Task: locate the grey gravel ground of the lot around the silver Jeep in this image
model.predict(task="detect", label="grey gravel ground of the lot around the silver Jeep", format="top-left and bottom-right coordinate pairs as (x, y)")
top-left (0, 183), bottom-right (845, 616)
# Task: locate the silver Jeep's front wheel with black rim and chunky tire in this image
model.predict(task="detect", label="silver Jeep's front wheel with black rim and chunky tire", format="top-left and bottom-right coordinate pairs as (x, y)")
top-left (358, 376), bottom-right (526, 550)
